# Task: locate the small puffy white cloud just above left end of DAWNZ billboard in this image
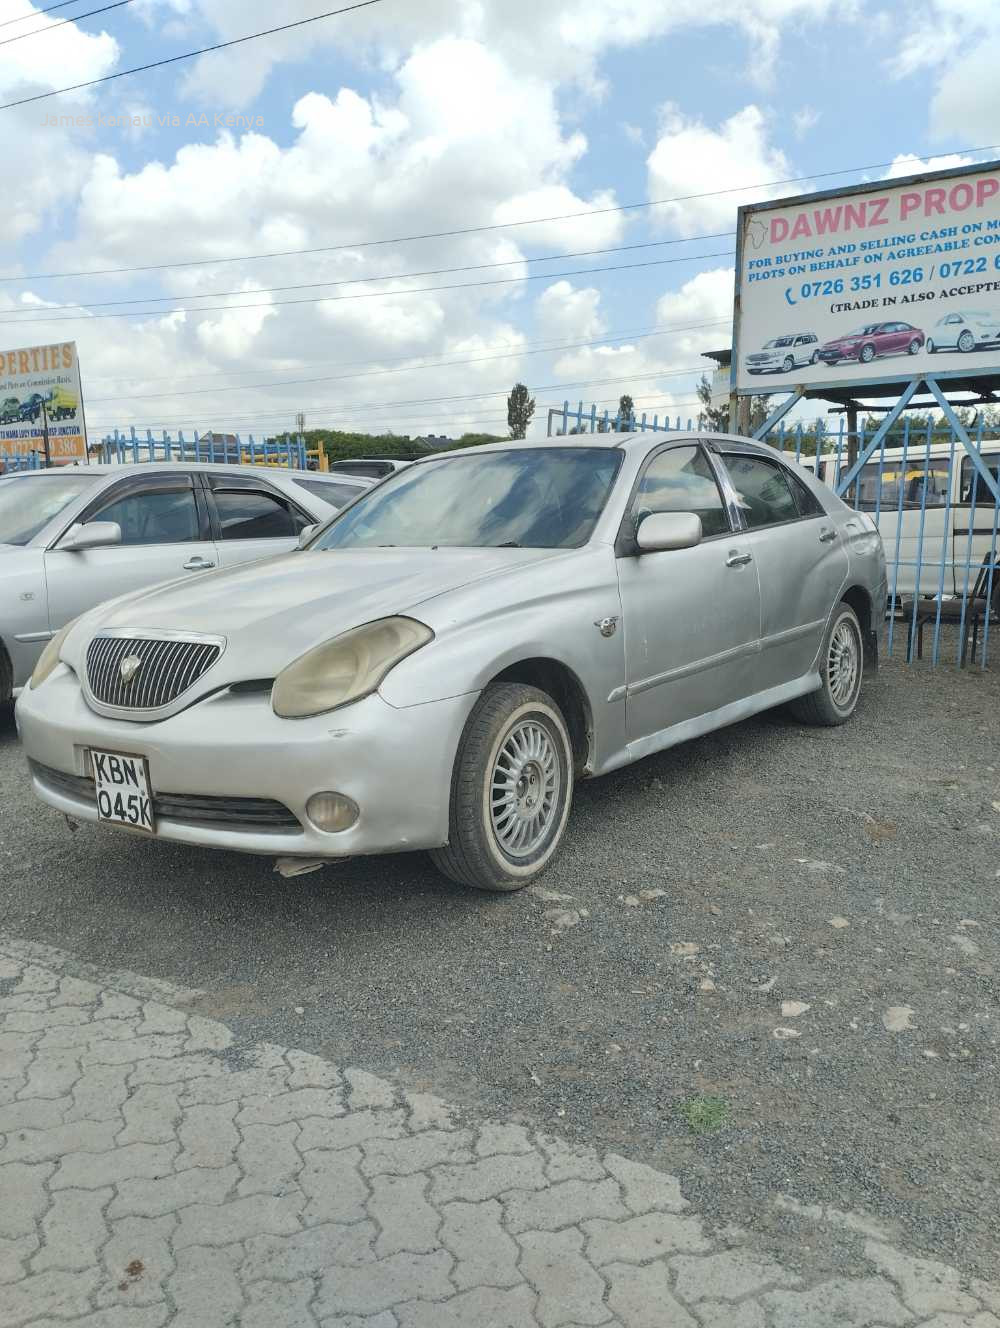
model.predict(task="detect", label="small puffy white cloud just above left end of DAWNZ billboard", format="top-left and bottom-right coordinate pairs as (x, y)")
top-left (647, 102), bottom-right (795, 235)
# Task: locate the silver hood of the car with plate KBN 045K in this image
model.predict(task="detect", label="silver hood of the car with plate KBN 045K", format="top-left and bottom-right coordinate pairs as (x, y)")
top-left (68, 548), bottom-right (566, 677)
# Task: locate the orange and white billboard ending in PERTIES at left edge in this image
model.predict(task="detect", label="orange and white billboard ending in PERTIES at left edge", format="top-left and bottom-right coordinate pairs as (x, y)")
top-left (0, 341), bottom-right (86, 463)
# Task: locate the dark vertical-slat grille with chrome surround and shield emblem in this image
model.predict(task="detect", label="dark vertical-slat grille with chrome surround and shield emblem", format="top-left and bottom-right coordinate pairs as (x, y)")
top-left (86, 636), bottom-right (222, 710)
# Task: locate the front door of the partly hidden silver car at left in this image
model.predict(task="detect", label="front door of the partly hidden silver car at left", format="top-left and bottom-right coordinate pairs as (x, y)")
top-left (45, 469), bottom-right (218, 631)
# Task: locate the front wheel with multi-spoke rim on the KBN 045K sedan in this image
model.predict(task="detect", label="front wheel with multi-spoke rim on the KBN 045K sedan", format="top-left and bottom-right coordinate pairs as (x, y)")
top-left (430, 683), bottom-right (574, 891)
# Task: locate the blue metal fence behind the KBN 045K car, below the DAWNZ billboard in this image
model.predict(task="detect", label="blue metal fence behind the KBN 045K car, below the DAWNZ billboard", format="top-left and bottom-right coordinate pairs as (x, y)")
top-left (548, 390), bottom-right (1000, 668)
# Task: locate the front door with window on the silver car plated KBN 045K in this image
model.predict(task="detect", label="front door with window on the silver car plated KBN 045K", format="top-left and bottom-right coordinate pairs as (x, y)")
top-left (618, 442), bottom-right (761, 746)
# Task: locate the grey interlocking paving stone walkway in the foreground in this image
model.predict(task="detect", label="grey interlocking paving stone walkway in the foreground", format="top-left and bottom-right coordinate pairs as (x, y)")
top-left (0, 936), bottom-right (1000, 1328)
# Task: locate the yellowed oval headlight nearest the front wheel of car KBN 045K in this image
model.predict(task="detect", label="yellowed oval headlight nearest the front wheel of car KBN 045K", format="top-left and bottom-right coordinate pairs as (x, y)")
top-left (271, 618), bottom-right (434, 720)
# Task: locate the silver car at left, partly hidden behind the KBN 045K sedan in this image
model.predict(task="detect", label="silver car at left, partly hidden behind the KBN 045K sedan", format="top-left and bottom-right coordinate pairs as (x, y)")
top-left (0, 462), bottom-right (372, 705)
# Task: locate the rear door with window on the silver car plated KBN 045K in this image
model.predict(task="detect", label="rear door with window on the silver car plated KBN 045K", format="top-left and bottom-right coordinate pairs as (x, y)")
top-left (722, 453), bottom-right (849, 692)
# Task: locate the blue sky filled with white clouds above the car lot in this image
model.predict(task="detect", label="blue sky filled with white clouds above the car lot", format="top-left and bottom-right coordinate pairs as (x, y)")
top-left (0, 0), bottom-right (1000, 441)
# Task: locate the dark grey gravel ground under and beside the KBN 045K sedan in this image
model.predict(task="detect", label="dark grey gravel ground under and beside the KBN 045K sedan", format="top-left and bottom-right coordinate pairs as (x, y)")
top-left (0, 661), bottom-right (1000, 1276)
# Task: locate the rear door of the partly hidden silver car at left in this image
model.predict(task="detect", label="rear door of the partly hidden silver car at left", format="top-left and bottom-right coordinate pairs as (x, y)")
top-left (205, 471), bottom-right (315, 567)
